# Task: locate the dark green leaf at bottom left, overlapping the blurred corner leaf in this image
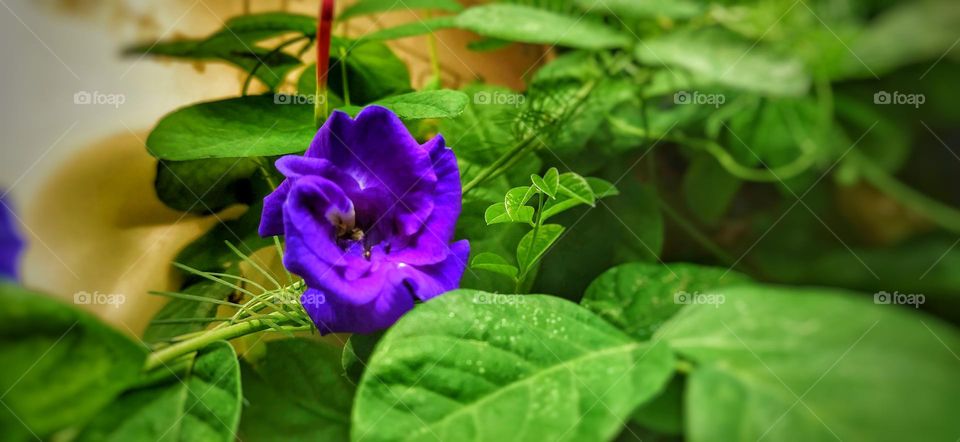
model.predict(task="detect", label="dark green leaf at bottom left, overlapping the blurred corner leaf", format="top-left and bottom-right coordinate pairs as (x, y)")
top-left (77, 341), bottom-right (242, 442)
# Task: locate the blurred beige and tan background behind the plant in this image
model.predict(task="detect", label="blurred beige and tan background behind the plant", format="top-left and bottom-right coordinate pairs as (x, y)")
top-left (0, 0), bottom-right (544, 334)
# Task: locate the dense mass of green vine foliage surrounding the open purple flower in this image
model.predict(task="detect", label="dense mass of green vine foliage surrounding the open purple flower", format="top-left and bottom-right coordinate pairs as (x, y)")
top-left (0, 0), bottom-right (960, 441)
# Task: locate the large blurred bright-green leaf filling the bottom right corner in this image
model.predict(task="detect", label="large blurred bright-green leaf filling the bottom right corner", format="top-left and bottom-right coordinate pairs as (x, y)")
top-left (656, 286), bottom-right (960, 442)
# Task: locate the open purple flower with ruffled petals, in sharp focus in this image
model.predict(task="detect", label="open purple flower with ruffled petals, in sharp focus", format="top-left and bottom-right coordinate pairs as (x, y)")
top-left (260, 106), bottom-right (470, 333)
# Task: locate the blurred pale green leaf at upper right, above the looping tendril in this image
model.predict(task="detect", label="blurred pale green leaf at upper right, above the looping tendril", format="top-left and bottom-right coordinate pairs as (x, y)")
top-left (636, 29), bottom-right (810, 95)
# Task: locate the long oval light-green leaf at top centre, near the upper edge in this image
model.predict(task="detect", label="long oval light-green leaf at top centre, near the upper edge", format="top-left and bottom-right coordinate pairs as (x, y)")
top-left (455, 4), bottom-right (631, 49)
